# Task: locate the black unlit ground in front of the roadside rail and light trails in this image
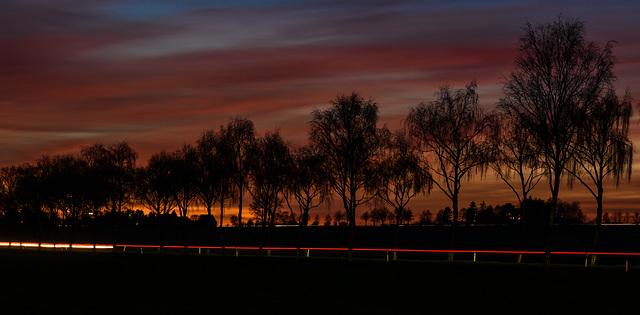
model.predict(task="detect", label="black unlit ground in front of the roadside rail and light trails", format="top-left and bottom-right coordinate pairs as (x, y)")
top-left (0, 249), bottom-right (640, 314)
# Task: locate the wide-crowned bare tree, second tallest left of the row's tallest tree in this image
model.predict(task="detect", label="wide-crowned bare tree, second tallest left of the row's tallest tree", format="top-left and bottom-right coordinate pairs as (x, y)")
top-left (406, 81), bottom-right (494, 254)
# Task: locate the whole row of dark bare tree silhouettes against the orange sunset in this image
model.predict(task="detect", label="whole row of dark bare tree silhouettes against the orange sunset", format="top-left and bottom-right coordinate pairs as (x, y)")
top-left (0, 17), bottom-right (633, 264)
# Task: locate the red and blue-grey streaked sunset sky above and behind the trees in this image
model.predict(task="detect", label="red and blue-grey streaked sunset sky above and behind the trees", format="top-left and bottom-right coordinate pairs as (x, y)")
top-left (0, 0), bottom-right (640, 222)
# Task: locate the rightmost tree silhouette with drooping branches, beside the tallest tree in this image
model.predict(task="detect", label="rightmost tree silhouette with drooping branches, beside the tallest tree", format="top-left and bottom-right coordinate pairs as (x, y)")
top-left (569, 90), bottom-right (633, 264)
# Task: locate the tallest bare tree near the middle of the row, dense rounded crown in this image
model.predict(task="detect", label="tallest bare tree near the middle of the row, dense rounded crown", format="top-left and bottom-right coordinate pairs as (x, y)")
top-left (309, 93), bottom-right (387, 260)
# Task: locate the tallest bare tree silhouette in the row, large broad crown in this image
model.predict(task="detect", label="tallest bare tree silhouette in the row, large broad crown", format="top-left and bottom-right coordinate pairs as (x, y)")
top-left (499, 17), bottom-right (615, 265)
